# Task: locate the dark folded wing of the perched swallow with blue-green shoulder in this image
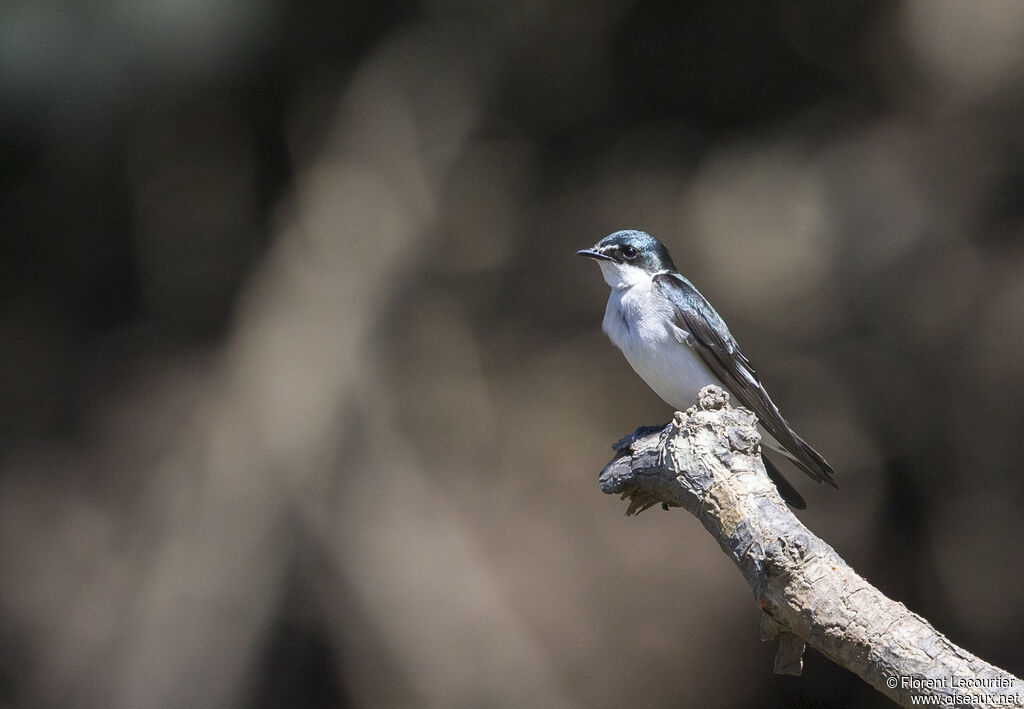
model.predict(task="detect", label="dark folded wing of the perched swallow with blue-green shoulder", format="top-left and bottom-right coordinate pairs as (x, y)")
top-left (654, 272), bottom-right (837, 488)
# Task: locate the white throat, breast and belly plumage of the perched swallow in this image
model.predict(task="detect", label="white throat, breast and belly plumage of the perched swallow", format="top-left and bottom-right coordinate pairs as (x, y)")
top-left (598, 261), bottom-right (792, 457)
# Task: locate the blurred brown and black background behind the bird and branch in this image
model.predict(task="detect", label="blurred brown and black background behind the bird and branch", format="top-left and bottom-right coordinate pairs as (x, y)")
top-left (0, 0), bottom-right (1024, 709)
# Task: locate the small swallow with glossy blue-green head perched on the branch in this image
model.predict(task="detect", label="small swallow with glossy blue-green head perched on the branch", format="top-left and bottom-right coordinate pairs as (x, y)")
top-left (577, 230), bottom-right (839, 509)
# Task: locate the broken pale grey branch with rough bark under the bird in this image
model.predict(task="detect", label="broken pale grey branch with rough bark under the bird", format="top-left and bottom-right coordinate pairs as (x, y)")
top-left (600, 386), bottom-right (1024, 706)
